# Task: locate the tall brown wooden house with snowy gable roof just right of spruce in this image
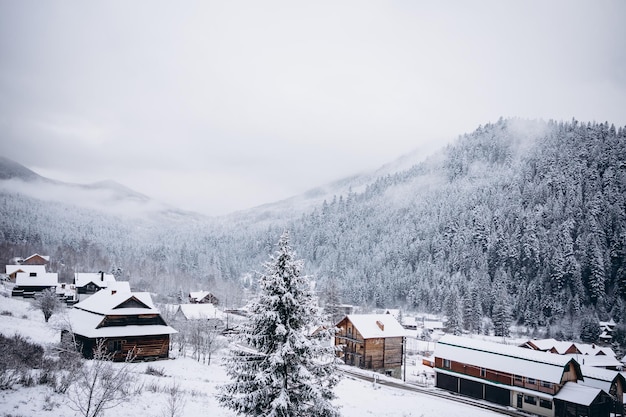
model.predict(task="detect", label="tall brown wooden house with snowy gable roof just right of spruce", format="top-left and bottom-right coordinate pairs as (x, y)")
top-left (335, 314), bottom-right (407, 378)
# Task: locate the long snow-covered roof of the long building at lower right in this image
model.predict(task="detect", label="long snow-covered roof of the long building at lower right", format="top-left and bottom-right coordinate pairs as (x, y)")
top-left (435, 335), bottom-right (573, 384)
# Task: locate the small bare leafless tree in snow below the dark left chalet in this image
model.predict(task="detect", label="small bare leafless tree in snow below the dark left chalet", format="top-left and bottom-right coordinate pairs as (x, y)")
top-left (69, 340), bottom-right (135, 417)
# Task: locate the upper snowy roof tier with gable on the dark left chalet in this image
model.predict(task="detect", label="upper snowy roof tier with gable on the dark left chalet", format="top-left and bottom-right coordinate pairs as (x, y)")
top-left (74, 288), bottom-right (159, 315)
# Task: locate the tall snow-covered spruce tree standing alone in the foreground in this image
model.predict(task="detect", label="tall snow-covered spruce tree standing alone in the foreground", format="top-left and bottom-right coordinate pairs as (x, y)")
top-left (218, 232), bottom-right (340, 417)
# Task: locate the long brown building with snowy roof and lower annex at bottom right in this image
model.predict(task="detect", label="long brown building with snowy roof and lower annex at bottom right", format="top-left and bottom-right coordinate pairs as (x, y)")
top-left (434, 335), bottom-right (622, 417)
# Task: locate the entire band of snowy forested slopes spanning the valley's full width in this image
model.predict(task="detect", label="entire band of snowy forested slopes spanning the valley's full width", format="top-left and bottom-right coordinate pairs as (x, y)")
top-left (0, 119), bottom-right (626, 330)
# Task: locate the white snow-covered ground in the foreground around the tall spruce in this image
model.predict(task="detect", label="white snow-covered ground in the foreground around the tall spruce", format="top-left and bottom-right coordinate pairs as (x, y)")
top-left (0, 297), bottom-right (499, 417)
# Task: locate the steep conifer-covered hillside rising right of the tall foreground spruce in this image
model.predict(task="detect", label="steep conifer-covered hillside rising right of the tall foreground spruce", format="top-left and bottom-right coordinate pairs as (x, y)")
top-left (292, 120), bottom-right (626, 329)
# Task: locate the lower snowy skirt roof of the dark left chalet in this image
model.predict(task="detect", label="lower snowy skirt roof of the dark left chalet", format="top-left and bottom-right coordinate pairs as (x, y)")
top-left (68, 306), bottom-right (177, 339)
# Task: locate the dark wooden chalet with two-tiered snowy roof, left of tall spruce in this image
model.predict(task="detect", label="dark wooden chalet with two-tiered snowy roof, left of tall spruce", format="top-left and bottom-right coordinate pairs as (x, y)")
top-left (68, 289), bottom-right (177, 361)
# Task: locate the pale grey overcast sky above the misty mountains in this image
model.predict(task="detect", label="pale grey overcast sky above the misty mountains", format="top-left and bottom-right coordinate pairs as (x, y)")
top-left (0, 0), bottom-right (626, 214)
